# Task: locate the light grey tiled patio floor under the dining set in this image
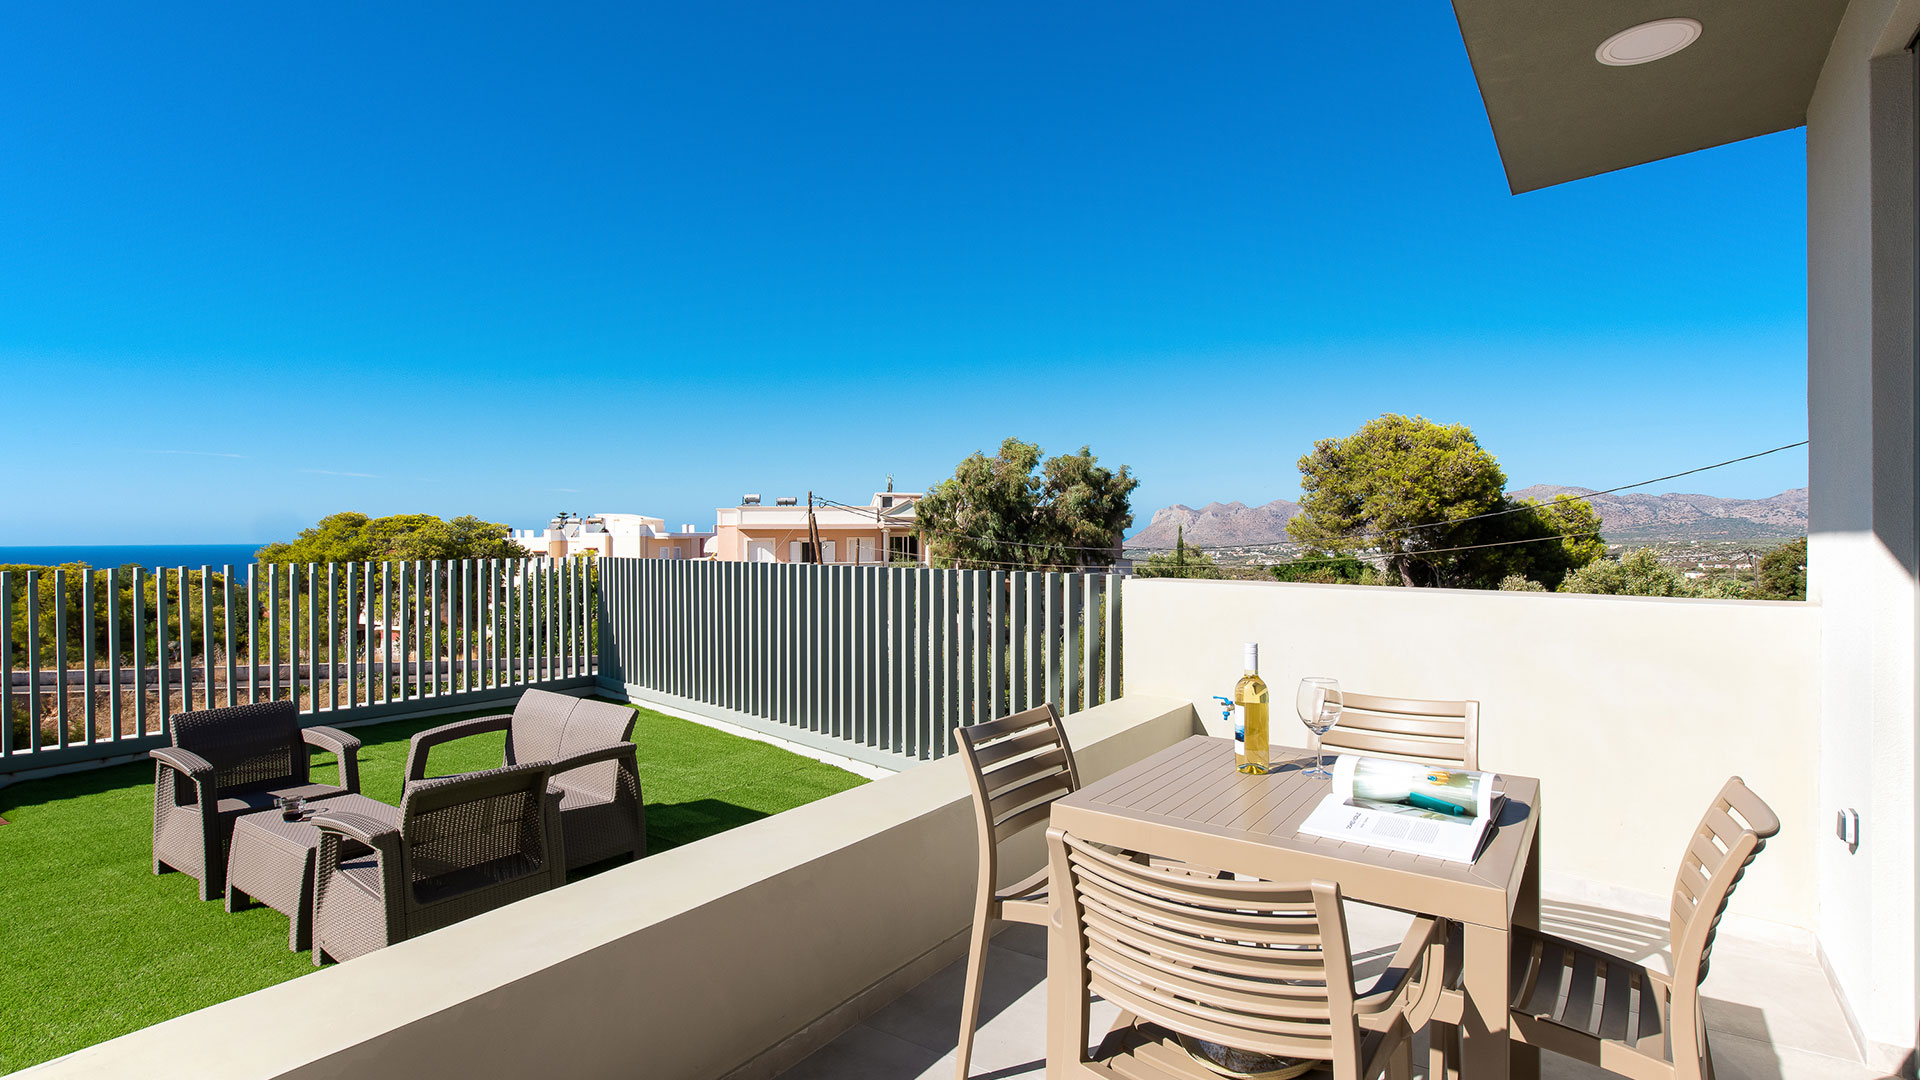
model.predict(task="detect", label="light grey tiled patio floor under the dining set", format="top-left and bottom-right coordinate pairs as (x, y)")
top-left (783, 899), bottom-right (1880, 1080)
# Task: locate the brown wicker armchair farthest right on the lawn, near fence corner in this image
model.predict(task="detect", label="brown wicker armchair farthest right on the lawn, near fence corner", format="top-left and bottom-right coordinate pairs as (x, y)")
top-left (407, 690), bottom-right (647, 871)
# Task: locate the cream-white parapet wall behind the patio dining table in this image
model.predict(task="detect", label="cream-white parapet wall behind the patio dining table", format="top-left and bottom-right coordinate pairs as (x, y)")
top-left (1125, 578), bottom-right (1830, 932)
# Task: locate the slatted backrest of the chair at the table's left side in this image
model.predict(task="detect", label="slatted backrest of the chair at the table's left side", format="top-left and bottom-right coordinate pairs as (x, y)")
top-left (954, 705), bottom-right (1079, 888)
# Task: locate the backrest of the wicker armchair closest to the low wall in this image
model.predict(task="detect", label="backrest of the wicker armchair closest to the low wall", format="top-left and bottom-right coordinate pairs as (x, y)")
top-left (399, 761), bottom-right (564, 905)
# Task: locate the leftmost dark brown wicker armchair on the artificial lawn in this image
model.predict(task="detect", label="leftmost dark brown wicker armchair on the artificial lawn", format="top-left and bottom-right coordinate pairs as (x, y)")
top-left (148, 701), bottom-right (361, 899)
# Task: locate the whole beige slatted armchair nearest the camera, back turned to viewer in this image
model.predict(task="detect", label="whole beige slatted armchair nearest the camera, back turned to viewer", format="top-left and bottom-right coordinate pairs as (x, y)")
top-left (1046, 828), bottom-right (1446, 1080)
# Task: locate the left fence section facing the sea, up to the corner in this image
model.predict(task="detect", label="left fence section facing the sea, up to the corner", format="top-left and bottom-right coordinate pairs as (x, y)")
top-left (0, 559), bottom-right (597, 774)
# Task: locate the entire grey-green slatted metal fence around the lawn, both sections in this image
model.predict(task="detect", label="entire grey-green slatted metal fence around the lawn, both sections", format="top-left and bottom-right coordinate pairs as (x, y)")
top-left (0, 559), bottom-right (1121, 776)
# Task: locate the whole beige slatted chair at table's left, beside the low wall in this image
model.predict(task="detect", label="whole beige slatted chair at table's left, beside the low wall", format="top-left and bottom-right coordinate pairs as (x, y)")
top-left (954, 705), bottom-right (1079, 1080)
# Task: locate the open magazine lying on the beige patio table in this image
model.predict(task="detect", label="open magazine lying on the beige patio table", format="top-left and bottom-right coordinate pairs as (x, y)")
top-left (1300, 753), bottom-right (1503, 863)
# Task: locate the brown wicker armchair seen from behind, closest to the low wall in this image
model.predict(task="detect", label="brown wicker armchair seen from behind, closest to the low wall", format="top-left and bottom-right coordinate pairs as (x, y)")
top-left (311, 761), bottom-right (566, 967)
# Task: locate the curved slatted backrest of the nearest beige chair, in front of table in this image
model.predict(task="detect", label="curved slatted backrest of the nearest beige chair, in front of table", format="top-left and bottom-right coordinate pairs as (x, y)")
top-left (1046, 828), bottom-right (1361, 1076)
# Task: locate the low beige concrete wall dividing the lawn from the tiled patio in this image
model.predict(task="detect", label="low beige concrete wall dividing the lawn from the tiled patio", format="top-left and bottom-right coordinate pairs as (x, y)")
top-left (15, 696), bottom-right (1194, 1080)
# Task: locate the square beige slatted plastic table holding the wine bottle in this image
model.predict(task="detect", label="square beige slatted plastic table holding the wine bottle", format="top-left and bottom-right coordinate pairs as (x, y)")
top-left (1046, 736), bottom-right (1540, 1080)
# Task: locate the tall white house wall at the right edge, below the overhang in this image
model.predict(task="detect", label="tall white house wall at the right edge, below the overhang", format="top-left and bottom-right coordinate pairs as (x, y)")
top-left (1807, 0), bottom-right (1920, 1065)
